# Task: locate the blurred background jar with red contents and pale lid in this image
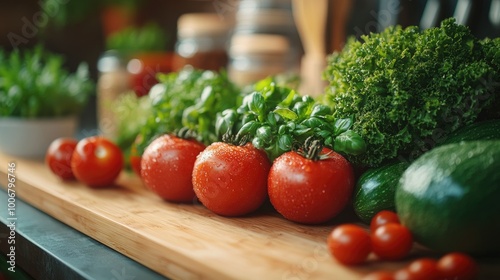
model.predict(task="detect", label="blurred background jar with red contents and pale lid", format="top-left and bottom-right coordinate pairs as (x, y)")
top-left (173, 13), bottom-right (234, 71)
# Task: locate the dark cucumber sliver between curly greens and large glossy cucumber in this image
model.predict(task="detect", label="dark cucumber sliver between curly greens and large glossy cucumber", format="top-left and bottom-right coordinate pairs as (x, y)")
top-left (439, 120), bottom-right (500, 146)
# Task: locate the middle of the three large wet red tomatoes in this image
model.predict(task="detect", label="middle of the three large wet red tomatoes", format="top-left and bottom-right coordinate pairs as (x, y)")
top-left (193, 142), bottom-right (271, 216)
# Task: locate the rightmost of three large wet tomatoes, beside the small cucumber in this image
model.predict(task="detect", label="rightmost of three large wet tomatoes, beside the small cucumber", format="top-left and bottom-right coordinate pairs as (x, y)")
top-left (268, 148), bottom-right (354, 224)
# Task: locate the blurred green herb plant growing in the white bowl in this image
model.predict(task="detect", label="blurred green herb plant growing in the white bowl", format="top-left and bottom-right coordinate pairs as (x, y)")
top-left (0, 46), bottom-right (95, 118)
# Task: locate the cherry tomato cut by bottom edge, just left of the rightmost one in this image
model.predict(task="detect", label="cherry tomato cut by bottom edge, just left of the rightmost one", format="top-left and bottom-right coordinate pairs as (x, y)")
top-left (394, 258), bottom-right (441, 280)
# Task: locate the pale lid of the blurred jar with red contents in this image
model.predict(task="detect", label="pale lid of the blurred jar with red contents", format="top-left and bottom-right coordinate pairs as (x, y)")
top-left (177, 13), bottom-right (233, 37)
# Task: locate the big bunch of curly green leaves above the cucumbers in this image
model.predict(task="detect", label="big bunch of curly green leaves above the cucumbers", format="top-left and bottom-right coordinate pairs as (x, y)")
top-left (323, 19), bottom-right (500, 167)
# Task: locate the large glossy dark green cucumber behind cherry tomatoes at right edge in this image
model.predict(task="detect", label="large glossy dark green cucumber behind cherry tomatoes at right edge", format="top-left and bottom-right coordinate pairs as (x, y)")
top-left (395, 140), bottom-right (500, 254)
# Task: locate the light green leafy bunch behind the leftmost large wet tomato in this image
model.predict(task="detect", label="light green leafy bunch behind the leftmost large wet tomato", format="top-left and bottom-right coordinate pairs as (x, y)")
top-left (136, 68), bottom-right (241, 154)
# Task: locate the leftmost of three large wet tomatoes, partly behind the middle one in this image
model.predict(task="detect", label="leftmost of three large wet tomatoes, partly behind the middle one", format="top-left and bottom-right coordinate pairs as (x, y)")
top-left (141, 135), bottom-right (205, 202)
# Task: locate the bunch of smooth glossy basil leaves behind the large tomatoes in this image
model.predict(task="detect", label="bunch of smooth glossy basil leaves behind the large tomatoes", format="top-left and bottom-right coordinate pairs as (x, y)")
top-left (216, 78), bottom-right (365, 161)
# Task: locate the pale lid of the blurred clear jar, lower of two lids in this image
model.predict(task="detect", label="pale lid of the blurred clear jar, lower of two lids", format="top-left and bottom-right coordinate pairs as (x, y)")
top-left (229, 34), bottom-right (290, 56)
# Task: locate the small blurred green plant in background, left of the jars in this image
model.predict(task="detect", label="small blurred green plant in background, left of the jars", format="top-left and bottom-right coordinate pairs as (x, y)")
top-left (106, 23), bottom-right (169, 53)
